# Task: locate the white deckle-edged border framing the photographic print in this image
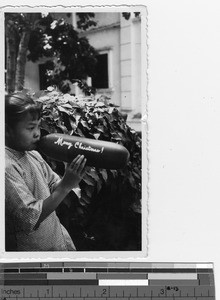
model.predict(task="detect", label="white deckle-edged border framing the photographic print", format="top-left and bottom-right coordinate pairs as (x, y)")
top-left (0, 5), bottom-right (149, 261)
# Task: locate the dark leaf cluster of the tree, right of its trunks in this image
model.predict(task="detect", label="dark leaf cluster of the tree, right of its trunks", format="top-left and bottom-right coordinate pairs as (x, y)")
top-left (28, 14), bottom-right (97, 93)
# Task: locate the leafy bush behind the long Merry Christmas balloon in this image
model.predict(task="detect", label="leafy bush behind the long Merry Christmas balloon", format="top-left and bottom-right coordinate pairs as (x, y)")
top-left (35, 90), bottom-right (141, 251)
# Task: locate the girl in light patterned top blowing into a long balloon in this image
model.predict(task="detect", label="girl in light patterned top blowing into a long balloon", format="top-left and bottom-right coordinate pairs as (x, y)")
top-left (5, 92), bottom-right (86, 251)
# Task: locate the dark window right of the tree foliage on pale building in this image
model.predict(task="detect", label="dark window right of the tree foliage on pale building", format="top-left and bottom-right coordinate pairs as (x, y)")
top-left (92, 53), bottom-right (109, 89)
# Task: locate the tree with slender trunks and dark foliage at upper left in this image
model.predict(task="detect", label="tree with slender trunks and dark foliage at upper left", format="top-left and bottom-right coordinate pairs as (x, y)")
top-left (5, 13), bottom-right (97, 92)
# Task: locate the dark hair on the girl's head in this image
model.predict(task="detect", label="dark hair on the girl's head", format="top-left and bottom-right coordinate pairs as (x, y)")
top-left (5, 91), bottom-right (41, 127)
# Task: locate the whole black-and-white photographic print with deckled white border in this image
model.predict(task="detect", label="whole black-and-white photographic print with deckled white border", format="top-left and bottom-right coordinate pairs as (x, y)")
top-left (1, 6), bottom-right (148, 258)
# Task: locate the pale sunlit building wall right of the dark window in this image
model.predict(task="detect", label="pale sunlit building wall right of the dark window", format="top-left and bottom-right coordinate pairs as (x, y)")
top-left (80, 13), bottom-right (142, 131)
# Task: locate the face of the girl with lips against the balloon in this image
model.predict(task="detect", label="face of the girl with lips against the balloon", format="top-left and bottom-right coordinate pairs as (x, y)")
top-left (6, 113), bottom-right (40, 151)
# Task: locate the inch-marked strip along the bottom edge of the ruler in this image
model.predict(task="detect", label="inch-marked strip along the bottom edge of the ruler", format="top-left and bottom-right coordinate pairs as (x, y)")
top-left (1, 286), bottom-right (215, 300)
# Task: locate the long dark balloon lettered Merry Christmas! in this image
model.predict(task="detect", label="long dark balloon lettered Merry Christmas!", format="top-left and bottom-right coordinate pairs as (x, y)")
top-left (38, 133), bottom-right (130, 170)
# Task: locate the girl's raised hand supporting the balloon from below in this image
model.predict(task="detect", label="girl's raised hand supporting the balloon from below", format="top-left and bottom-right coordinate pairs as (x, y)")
top-left (60, 155), bottom-right (86, 191)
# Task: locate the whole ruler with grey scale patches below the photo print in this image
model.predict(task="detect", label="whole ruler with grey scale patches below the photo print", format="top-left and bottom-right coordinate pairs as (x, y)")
top-left (0, 262), bottom-right (215, 300)
